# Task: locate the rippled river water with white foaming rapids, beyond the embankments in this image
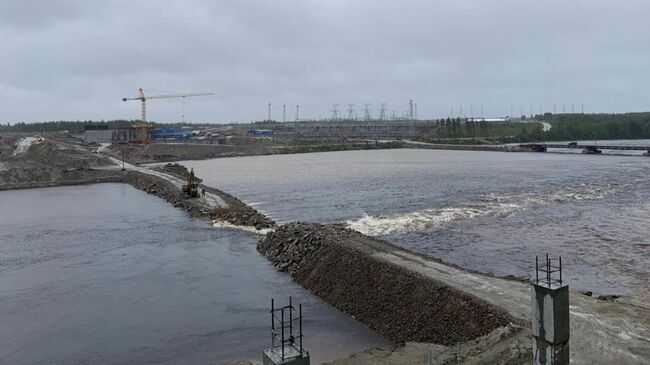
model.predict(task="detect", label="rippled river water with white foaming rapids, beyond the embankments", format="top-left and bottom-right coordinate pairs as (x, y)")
top-left (182, 149), bottom-right (650, 300)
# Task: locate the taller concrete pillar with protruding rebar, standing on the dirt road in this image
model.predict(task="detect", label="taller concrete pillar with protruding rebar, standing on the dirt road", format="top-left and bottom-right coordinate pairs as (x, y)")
top-left (531, 255), bottom-right (569, 365)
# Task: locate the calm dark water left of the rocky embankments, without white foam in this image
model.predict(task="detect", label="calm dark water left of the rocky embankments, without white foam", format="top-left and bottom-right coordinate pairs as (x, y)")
top-left (0, 184), bottom-right (386, 365)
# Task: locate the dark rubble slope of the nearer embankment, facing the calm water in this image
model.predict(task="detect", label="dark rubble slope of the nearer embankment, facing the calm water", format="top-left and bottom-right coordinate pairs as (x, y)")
top-left (257, 223), bottom-right (511, 345)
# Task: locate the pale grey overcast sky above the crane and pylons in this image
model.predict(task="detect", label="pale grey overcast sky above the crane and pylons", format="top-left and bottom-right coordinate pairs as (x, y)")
top-left (0, 0), bottom-right (650, 123)
